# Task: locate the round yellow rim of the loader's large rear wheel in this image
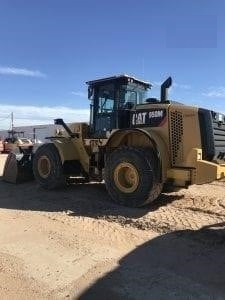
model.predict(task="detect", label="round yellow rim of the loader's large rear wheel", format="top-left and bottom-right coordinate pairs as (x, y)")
top-left (114, 162), bottom-right (140, 193)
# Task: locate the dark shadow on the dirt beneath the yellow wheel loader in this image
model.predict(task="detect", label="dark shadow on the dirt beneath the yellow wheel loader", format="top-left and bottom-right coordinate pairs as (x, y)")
top-left (0, 181), bottom-right (183, 218)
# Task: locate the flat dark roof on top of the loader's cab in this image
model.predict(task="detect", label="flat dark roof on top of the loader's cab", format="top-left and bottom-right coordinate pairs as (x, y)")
top-left (86, 74), bottom-right (152, 89)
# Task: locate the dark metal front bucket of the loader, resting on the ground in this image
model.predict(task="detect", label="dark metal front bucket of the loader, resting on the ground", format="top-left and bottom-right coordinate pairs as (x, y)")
top-left (2, 153), bottom-right (34, 183)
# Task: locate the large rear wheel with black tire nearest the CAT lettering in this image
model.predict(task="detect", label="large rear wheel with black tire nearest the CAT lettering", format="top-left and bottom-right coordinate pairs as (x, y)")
top-left (105, 147), bottom-right (162, 207)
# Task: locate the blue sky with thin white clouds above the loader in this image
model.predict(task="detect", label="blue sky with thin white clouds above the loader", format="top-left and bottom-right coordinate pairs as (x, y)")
top-left (0, 0), bottom-right (225, 129)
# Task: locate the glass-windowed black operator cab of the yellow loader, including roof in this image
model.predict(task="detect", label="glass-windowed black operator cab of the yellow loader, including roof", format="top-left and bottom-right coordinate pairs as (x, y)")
top-left (87, 75), bottom-right (151, 138)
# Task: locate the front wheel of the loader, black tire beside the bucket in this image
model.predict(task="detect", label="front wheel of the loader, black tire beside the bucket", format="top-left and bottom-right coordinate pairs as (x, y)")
top-left (33, 143), bottom-right (66, 190)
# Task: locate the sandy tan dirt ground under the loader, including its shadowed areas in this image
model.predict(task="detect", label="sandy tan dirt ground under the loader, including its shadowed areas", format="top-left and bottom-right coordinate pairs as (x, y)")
top-left (0, 154), bottom-right (225, 299)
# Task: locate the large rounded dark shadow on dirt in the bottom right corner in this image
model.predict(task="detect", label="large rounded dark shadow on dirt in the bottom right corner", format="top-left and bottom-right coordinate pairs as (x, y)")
top-left (77, 222), bottom-right (225, 300)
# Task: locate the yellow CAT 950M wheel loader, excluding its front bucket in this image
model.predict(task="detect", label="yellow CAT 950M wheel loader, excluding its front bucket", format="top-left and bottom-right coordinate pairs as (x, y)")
top-left (3, 75), bottom-right (225, 207)
